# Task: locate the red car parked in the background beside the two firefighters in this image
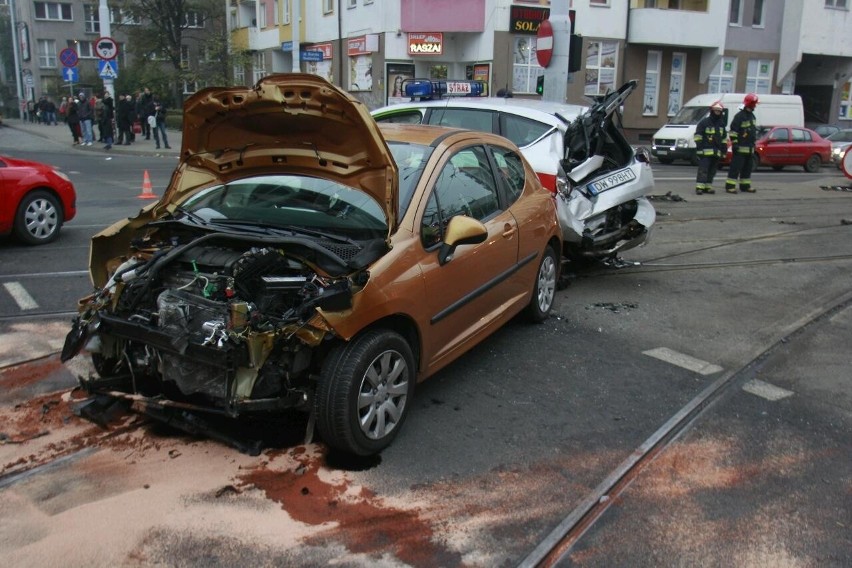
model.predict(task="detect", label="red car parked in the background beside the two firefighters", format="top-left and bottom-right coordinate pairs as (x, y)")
top-left (719, 126), bottom-right (831, 173)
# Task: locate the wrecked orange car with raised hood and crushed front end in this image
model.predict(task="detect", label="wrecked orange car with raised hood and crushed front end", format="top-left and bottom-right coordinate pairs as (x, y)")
top-left (63, 74), bottom-right (561, 455)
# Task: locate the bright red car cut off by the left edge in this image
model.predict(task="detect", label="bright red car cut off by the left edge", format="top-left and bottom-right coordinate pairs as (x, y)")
top-left (0, 156), bottom-right (77, 245)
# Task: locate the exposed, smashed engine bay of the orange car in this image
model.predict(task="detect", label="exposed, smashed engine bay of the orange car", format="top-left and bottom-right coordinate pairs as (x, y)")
top-left (62, 221), bottom-right (370, 416)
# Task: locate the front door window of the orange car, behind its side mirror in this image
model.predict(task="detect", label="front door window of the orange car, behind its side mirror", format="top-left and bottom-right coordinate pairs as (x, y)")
top-left (420, 146), bottom-right (500, 249)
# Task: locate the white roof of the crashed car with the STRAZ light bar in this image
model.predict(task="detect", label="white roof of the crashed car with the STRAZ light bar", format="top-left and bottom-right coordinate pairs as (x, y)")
top-left (371, 97), bottom-right (588, 127)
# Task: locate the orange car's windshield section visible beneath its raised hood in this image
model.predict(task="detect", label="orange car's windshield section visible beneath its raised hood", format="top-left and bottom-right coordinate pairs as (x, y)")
top-left (182, 175), bottom-right (388, 240)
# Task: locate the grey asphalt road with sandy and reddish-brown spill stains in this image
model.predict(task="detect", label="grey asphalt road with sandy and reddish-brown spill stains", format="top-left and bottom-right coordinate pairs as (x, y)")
top-left (0, 125), bottom-right (852, 566)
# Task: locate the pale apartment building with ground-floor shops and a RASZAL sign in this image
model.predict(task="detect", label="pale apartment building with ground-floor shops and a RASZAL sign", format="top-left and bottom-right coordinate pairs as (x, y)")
top-left (228, 0), bottom-right (852, 140)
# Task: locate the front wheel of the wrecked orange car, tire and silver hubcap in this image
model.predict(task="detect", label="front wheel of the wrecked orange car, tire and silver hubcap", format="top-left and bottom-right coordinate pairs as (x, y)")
top-left (315, 329), bottom-right (416, 456)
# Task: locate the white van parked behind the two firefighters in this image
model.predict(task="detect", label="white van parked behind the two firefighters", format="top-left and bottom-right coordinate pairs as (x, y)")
top-left (651, 93), bottom-right (805, 165)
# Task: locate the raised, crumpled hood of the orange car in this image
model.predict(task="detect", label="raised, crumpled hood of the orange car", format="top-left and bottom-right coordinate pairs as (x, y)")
top-left (166, 73), bottom-right (399, 231)
